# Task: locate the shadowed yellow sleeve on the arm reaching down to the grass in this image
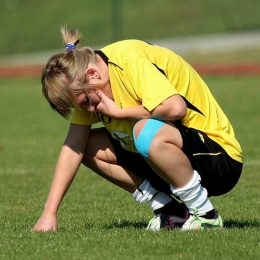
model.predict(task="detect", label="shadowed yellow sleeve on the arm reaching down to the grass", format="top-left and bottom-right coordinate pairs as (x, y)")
top-left (70, 109), bottom-right (100, 125)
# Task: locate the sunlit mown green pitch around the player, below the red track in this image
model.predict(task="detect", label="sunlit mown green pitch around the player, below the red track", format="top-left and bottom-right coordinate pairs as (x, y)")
top-left (0, 76), bottom-right (260, 260)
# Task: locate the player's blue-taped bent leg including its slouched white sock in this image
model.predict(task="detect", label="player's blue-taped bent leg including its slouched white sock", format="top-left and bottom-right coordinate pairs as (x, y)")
top-left (134, 119), bottom-right (213, 214)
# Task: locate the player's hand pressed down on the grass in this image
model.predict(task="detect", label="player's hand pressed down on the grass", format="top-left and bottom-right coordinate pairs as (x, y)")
top-left (32, 212), bottom-right (58, 232)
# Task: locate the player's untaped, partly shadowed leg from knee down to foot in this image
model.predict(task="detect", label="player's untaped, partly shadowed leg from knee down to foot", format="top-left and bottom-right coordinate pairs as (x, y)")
top-left (82, 129), bottom-right (187, 230)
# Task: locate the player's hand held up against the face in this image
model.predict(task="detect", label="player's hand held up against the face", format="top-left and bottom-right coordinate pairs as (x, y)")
top-left (96, 89), bottom-right (121, 118)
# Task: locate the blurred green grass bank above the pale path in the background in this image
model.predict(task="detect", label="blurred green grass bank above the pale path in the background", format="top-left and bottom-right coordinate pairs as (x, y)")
top-left (0, 0), bottom-right (260, 55)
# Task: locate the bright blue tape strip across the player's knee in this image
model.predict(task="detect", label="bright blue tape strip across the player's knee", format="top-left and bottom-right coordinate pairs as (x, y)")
top-left (133, 119), bottom-right (164, 158)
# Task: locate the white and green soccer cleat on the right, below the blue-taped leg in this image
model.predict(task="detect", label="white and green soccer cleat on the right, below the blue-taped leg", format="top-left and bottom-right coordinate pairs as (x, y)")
top-left (181, 209), bottom-right (223, 231)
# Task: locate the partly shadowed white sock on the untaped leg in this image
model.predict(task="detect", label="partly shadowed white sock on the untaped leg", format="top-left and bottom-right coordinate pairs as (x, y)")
top-left (132, 180), bottom-right (172, 210)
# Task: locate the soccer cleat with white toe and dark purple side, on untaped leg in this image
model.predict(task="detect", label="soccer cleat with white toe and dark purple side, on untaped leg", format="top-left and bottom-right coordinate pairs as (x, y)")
top-left (146, 211), bottom-right (189, 231)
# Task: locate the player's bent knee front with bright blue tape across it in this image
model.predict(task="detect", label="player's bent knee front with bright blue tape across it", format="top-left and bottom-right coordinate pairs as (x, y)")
top-left (133, 119), bottom-right (164, 158)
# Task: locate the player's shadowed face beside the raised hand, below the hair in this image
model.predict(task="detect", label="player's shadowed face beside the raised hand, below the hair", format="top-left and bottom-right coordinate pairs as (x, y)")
top-left (77, 88), bottom-right (100, 112)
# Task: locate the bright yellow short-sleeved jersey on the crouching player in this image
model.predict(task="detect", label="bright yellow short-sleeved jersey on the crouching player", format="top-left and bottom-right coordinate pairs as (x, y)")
top-left (71, 40), bottom-right (242, 162)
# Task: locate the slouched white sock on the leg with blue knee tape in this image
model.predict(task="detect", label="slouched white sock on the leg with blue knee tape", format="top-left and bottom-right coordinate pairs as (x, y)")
top-left (171, 171), bottom-right (213, 214)
